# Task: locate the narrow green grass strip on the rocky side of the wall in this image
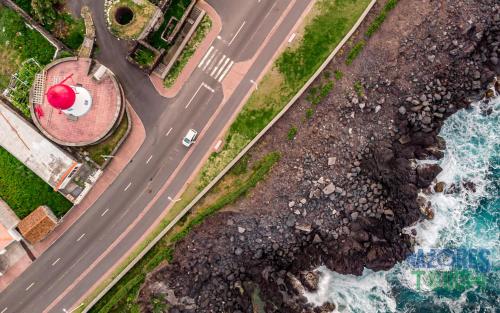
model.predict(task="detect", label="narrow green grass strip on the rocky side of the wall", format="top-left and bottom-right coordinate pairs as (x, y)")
top-left (90, 153), bottom-right (280, 313)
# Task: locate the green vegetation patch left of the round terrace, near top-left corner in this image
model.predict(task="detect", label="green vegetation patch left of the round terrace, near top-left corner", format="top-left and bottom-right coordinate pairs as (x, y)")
top-left (0, 5), bottom-right (55, 89)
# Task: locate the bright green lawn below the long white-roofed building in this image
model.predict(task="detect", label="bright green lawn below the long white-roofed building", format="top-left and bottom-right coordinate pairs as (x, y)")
top-left (0, 147), bottom-right (72, 218)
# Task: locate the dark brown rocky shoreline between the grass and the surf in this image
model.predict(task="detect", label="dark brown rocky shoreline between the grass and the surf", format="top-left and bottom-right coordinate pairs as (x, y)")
top-left (139, 0), bottom-right (500, 312)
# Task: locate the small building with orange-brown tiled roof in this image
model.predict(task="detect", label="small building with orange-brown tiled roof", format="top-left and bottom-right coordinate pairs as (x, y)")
top-left (17, 206), bottom-right (57, 244)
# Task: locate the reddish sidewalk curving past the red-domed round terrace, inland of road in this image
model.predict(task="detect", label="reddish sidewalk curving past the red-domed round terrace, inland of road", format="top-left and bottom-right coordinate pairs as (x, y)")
top-left (0, 104), bottom-right (146, 292)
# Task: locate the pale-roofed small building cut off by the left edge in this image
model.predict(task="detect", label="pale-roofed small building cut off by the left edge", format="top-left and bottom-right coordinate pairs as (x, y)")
top-left (0, 199), bottom-right (26, 276)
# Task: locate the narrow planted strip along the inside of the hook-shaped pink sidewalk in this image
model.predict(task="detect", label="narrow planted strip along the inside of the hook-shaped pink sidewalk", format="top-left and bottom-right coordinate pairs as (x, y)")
top-left (165, 15), bottom-right (212, 88)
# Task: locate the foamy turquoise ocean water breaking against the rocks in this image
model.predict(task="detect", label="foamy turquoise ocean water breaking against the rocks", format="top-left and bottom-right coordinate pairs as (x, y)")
top-left (306, 93), bottom-right (500, 313)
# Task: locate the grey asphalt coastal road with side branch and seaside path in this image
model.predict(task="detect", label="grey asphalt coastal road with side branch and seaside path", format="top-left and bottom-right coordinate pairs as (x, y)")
top-left (0, 0), bottom-right (310, 313)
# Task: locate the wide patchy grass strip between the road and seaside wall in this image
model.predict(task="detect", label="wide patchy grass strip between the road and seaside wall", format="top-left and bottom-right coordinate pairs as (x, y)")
top-left (198, 0), bottom-right (370, 186)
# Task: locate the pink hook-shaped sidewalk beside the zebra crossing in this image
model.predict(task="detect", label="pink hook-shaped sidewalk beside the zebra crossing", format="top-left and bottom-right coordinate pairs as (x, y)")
top-left (149, 0), bottom-right (222, 98)
